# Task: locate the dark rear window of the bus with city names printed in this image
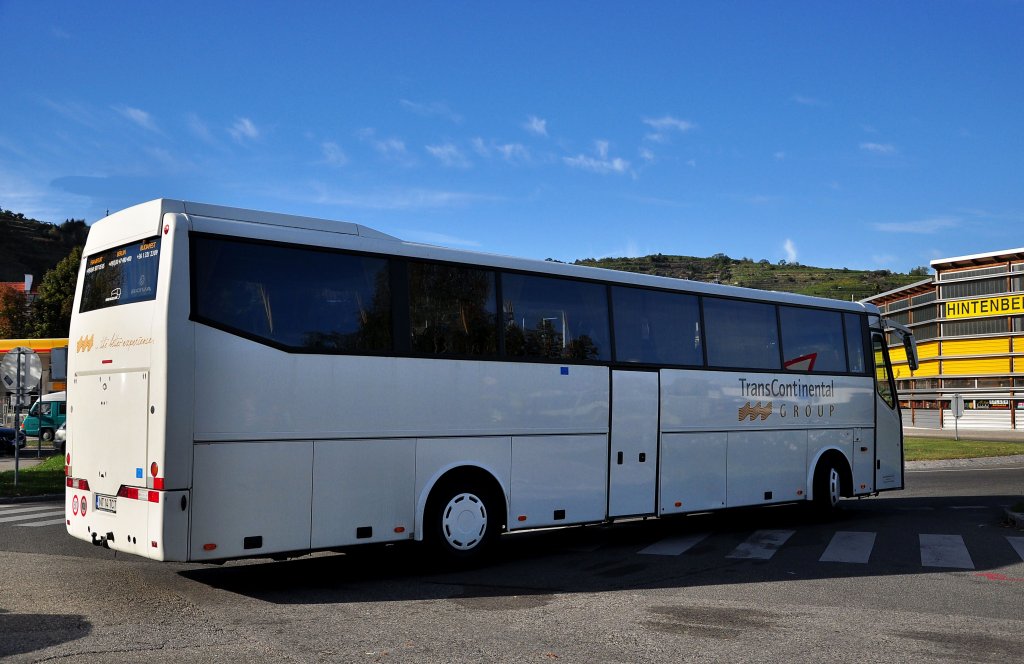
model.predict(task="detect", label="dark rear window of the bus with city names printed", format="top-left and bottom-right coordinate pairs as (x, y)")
top-left (79, 236), bottom-right (160, 313)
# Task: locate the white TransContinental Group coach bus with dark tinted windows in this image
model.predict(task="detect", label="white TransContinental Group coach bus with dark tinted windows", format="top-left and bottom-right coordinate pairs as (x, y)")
top-left (66, 200), bottom-right (913, 562)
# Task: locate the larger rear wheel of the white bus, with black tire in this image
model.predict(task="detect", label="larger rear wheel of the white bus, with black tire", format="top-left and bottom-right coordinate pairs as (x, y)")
top-left (425, 478), bottom-right (502, 563)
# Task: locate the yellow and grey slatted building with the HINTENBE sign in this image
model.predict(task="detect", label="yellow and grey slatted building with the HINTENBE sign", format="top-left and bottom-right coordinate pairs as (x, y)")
top-left (864, 248), bottom-right (1024, 429)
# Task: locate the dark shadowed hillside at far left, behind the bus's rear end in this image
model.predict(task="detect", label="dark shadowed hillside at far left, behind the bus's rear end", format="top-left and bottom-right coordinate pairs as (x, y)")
top-left (0, 209), bottom-right (89, 284)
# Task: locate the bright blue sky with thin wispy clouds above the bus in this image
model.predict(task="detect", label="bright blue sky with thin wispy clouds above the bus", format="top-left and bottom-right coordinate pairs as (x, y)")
top-left (0, 0), bottom-right (1024, 272)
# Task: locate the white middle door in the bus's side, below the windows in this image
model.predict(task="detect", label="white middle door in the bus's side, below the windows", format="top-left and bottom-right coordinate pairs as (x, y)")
top-left (608, 371), bottom-right (659, 516)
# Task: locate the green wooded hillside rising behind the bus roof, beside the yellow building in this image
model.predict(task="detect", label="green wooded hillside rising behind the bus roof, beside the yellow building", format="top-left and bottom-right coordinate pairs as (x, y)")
top-left (575, 254), bottom-right (928, 300)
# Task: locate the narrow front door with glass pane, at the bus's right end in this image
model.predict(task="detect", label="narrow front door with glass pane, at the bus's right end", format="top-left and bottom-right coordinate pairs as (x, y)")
top-left (871, 332), bottom-right (903, 491)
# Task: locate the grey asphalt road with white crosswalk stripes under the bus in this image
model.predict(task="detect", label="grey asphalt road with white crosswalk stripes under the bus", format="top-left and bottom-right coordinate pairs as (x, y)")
top-left (0, 462), bottom-right (1024, 663)
